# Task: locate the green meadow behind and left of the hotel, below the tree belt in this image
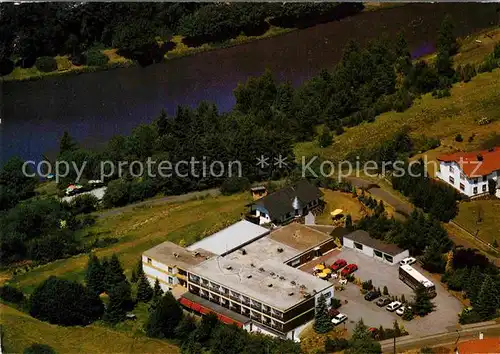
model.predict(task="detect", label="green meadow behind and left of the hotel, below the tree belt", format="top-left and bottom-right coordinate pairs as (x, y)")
top-left (7, 193), bottom-right (250, 293)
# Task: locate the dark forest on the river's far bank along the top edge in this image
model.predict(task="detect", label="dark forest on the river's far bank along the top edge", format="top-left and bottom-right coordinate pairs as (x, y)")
top-left (0, 2), bottom-right (363, 71)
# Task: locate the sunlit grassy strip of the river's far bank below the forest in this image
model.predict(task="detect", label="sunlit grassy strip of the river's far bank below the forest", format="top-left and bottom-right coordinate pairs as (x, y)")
top-left (0, 2), bottom-right (406, 82)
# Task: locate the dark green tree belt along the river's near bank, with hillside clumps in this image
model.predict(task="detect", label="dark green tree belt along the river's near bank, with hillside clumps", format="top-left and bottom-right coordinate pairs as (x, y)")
top-left (0, 18), bottom-right (500, 264)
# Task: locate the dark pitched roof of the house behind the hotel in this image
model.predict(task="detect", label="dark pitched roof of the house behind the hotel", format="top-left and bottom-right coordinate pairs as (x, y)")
top-left (253, 180), bottom-right (323, 219)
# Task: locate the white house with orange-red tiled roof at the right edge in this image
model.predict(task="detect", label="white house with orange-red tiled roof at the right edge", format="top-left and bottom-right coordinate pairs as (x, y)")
top-left (436, 147), bottom-right (500, 198)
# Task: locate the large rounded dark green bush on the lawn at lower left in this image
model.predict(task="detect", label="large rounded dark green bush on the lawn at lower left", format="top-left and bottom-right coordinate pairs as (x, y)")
top-left (30, 276), bottom-right (104, 326)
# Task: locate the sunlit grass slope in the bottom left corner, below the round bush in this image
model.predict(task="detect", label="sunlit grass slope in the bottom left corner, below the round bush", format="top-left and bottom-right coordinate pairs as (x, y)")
top-left (0, 304), bottom-right (179, 354)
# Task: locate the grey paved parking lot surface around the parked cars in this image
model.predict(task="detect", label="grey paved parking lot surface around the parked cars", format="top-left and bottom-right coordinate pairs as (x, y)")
top-left (302, 248), bottom-right (462, 336)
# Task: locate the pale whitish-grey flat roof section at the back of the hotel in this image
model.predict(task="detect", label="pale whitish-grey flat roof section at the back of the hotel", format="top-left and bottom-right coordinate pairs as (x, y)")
top-left (187, 220), bottom-right (269, 255)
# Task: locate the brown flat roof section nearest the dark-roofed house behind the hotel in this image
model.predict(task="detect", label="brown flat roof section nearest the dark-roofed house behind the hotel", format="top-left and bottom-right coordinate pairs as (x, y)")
top-left (269, 223), bottom-right (332, 253)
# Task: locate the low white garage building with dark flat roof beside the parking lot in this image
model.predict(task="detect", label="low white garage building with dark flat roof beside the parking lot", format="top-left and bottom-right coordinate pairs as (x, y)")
top-left (343, 230), bottom-right (410, 265)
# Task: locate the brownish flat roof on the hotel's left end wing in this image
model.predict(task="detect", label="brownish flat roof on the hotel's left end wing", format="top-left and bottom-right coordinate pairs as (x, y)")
top-left (143, 241), bottom-right (214, 269)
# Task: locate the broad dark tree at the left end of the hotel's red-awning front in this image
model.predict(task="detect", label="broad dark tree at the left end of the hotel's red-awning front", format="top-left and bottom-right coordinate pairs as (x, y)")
top-left (145, 292), bottom-right (183, 338)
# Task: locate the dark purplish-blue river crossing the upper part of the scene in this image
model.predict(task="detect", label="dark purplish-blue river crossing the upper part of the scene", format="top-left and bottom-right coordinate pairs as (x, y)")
top-left (0, 3), bottom-right (499, 160)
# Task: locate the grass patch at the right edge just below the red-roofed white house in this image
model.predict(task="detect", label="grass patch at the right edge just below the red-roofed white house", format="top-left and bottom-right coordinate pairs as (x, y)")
top-left (454, 199), bottom-right (500, 243)
